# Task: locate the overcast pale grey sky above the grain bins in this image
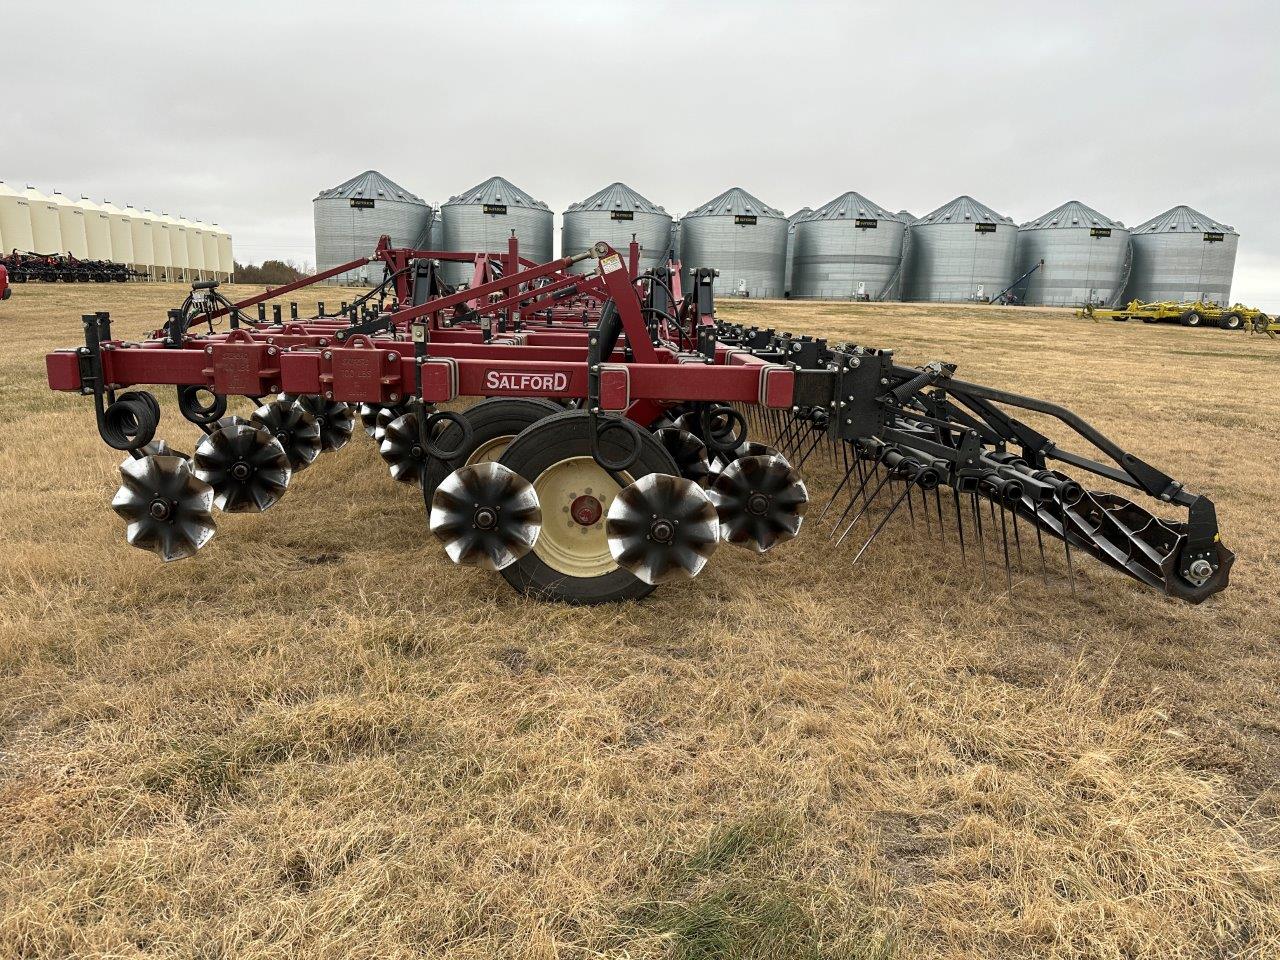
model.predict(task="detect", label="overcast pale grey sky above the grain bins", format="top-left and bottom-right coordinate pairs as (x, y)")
top-left (10, 0), bottom-right (1280, 310)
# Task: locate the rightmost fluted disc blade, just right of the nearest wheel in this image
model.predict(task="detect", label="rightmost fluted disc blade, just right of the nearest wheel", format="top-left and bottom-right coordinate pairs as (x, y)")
top-left (708, 454), bottom-right (809, 553)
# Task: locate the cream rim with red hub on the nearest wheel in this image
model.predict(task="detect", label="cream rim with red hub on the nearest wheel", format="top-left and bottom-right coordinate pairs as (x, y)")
top-left (534, 457), bottom-right (631, 577)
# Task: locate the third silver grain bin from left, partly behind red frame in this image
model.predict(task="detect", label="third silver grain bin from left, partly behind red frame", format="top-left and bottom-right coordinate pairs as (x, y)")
top-left (561, 183), bottom-right (672, 274)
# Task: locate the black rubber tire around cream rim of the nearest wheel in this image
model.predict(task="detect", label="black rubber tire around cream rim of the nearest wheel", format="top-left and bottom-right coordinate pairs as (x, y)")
top-left (499, 410), bottom-right (680, 605)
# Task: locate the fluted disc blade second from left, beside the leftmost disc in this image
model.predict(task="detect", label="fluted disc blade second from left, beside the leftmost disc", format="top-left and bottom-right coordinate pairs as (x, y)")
top-left (192, 422), bottom-right (293, 513)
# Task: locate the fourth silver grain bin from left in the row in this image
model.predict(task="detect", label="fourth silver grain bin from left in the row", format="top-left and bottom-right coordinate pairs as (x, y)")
top-left (680, 187), bottom-right (788, 297)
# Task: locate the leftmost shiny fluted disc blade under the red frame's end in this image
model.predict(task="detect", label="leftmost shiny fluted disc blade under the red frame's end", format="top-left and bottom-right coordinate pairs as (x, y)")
top-left (111, 456), bottom-right (218, 562)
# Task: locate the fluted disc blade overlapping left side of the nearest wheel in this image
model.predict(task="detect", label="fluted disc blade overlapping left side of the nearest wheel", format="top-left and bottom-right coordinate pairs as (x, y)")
top-left (431, 461), bottom-right (543, 570)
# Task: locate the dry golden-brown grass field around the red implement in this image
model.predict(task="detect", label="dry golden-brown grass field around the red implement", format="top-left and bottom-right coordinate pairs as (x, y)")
top-left (0, 285), bottom-right (1280, 960)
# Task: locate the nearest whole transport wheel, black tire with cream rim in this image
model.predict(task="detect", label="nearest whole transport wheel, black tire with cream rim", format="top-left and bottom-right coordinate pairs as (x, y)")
top-left (499, 410), bottom-right (680, 605)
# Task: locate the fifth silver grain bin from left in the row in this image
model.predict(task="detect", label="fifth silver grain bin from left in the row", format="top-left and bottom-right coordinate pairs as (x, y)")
top-left (791, 191), bottom-right (906, 300)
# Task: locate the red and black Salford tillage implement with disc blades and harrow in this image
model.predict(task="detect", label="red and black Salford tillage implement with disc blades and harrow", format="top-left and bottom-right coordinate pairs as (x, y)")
top-left (46, 238), bottom-right (1234, 603)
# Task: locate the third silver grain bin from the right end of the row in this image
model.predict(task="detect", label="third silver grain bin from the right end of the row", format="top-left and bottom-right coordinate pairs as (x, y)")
top-left (902, 197), bottom-right (1018, 302)
